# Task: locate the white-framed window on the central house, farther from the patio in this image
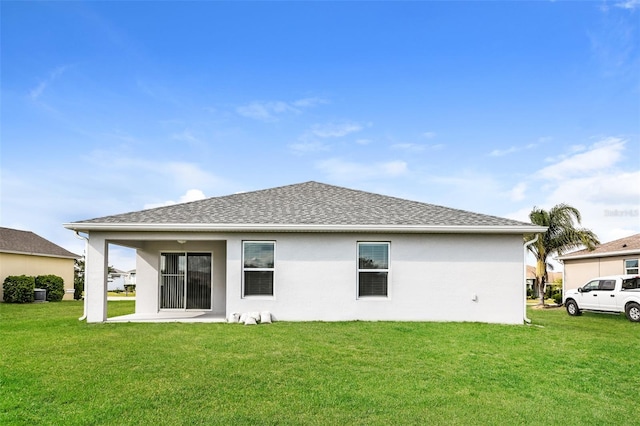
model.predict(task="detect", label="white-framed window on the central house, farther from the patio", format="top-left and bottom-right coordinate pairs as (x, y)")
top-left (358, 242), bottom-right (390, 297)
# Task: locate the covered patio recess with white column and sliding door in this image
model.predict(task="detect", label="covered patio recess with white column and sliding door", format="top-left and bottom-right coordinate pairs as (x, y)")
top-left (76, 231), bottom-right (227, 323)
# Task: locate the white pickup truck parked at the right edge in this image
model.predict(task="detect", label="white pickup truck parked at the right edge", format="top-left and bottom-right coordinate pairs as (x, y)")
top-left (564, 275), bottom-right (640, 322)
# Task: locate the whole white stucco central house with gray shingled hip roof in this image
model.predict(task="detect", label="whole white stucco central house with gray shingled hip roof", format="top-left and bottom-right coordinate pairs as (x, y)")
top-left (64, 182), bottom-right (546, 324)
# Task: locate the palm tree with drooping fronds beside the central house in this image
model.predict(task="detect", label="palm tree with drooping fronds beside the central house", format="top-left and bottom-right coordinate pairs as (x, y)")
top-left (524, 204), bottom-right (600, 305)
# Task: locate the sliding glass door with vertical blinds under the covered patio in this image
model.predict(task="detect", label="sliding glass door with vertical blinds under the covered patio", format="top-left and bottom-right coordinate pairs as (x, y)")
top-left (160, 253), bottom-right (211, 310)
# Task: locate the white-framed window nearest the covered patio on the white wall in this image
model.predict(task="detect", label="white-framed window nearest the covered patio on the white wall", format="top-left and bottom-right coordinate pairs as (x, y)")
top-left (242, 241), bottom-right (276, 296)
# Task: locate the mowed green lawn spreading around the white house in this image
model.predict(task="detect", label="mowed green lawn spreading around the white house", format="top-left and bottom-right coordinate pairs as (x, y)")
top-left (0, 301), bottom-right (640, 425)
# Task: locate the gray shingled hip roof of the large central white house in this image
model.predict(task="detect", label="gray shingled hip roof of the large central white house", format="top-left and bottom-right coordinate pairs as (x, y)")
top-left (65, 182), bottom-right (535, 232)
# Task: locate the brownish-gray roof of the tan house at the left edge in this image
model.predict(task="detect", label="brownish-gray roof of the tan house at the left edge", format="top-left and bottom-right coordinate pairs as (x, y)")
top-left (0, 228), bottom-right (80, 259)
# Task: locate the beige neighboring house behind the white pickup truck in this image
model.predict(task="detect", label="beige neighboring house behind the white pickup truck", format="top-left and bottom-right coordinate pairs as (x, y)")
top-left (558, 234), bottom-right (640, 290)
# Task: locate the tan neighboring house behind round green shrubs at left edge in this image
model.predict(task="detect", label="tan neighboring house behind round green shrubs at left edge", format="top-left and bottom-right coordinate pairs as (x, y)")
top-left (0, 228), bottom-right (79, 300)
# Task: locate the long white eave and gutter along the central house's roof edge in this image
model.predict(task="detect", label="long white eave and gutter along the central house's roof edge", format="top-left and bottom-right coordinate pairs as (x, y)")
top-left (63, 222), bottom-right (547, 234)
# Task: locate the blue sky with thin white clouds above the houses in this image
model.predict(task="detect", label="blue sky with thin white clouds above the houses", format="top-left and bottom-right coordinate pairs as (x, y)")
top-left (0, 0), bottom-right (640, 269)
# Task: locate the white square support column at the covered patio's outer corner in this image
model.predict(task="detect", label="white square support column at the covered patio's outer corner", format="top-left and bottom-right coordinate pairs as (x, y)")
top-left (85, 234), bottom-right (108, 322)
